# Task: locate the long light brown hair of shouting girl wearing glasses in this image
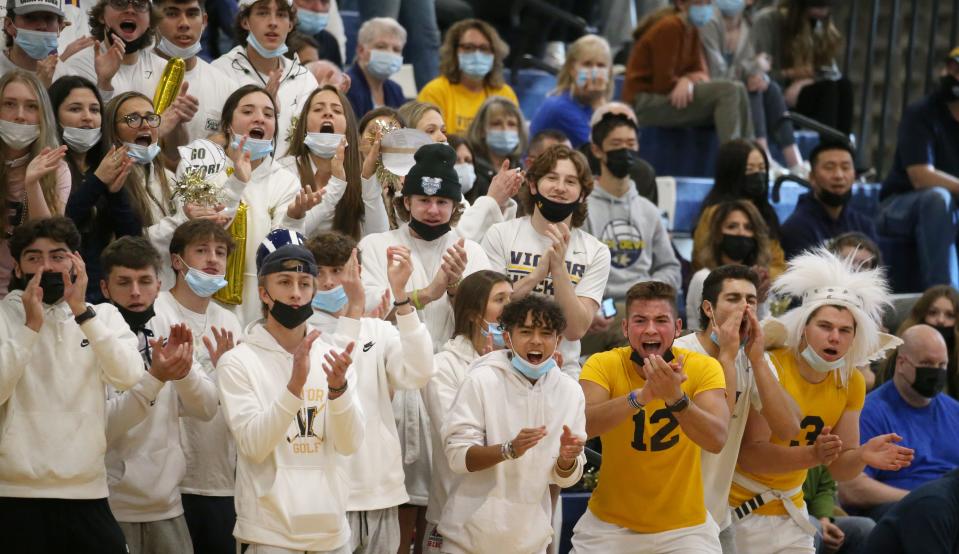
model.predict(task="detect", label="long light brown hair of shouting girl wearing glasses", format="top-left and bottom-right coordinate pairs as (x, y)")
top-left (100, 91), bottom-right (176, 228)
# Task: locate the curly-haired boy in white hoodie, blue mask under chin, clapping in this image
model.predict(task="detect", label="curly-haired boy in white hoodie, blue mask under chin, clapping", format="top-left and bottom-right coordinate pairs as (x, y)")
top-left (439, 294), bottom-right (586, 554)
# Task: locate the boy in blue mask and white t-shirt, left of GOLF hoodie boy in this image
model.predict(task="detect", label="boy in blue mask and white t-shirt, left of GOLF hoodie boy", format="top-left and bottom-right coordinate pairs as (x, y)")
top-left (167, 219), bottom-right (243, 554)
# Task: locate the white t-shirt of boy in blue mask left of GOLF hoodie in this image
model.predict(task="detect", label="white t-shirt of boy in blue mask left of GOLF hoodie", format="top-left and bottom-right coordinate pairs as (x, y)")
top-left (154, 292), bottom-right (243, 496)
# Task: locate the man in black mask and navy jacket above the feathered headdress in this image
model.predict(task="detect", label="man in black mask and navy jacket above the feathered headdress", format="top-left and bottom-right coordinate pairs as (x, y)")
top-left (779, 142), bottom-right (879, 260)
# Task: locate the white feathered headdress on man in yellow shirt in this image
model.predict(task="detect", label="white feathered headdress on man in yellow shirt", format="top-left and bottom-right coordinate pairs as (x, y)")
top-left (763, 248), bottom-right (902, 386)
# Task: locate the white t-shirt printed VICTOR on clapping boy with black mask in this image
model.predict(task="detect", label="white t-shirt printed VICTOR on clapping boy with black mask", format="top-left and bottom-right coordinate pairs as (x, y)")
top-left (483, 216), bottom-right (610, 379)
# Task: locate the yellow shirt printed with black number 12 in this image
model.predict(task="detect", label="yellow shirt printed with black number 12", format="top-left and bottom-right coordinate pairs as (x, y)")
top-left (579, 346), bottom-right (726, 533)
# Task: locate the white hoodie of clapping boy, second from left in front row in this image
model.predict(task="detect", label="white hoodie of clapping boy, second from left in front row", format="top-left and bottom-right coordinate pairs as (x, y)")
top-left (104, 293), bottom-right (217, 523)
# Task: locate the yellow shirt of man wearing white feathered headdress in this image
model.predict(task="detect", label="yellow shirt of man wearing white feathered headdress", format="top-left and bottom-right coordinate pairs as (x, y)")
top-left (729, 348), bottom-right (866, 516)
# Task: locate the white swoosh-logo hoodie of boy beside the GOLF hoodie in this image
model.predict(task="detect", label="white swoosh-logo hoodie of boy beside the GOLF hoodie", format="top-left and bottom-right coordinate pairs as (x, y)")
top-left (310, 311), bottom-right (433, 512)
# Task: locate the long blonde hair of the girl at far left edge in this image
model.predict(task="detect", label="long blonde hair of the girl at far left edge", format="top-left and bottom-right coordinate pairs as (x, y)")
top-left (0, 69), bottom-right (66, 241)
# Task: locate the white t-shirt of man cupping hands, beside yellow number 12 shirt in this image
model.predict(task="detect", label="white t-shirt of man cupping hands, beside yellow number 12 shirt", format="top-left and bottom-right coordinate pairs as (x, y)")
top-left (673, 333), bottom-right (779, 528)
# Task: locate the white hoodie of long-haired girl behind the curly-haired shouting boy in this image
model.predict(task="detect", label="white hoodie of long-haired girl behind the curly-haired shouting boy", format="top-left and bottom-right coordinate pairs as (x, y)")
top-left (423, 335), bottom-right (480, 524)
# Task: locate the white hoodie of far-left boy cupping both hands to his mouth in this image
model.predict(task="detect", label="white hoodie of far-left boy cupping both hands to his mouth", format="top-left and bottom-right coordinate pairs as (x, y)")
top-left (0, 290), bottom-right (143, 499)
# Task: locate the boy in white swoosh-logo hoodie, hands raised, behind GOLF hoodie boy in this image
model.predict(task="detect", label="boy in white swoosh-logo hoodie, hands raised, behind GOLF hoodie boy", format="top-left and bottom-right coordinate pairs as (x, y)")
top-left (307, 231), bottom-right (433, 554)
